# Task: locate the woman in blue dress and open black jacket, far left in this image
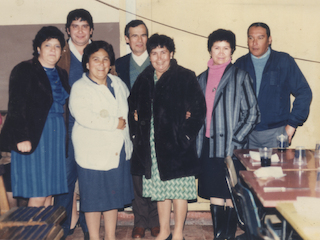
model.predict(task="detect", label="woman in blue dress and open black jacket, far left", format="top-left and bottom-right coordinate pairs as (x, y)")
top-left (1, 26), bottom-right (70, 206)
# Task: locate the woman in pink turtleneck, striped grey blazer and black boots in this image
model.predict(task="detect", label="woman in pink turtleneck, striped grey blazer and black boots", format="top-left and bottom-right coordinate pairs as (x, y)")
top-left (197, 29), bottom-right (260, 239)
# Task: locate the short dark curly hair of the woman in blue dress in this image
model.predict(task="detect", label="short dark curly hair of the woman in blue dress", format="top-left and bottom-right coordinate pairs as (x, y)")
top-left (33, 26), bottom-right (65, 57)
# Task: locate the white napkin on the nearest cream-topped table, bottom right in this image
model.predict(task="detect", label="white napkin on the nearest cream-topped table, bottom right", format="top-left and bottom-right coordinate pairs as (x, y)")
top-left (293, 197), bottom-right (320, 221)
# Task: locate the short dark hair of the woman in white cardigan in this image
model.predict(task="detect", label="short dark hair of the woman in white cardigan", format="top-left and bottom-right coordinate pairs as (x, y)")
top-left (82, 41), bottom-right (115, 72)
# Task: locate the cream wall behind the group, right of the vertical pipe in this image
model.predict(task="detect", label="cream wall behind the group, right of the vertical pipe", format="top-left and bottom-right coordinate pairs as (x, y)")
top-left (125, 0), bottom-right (320, 148)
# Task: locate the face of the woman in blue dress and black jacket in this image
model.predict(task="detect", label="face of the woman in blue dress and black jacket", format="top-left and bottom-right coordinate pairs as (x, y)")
top-left (37, 38), bottom-right (61, 68)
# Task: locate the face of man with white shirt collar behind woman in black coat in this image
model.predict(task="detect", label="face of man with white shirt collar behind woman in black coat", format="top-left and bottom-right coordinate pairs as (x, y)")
top-left (125, 24), bottom-right (148, 56)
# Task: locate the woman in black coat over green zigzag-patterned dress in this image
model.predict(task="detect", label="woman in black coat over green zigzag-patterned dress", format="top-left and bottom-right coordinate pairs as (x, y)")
top-left (128, 34), bottom-right (205, 240)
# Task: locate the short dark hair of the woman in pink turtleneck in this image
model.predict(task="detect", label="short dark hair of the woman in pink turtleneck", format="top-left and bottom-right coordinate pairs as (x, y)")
top-left (208, 29), bottom-right (236, 54)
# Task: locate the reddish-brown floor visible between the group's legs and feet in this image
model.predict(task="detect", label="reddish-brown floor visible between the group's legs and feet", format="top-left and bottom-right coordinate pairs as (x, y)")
top-left (67, 225), bottom-right (243, 240)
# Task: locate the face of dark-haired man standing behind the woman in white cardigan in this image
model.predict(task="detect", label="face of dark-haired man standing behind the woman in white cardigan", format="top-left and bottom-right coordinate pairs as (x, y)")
top-left (67, 19), bottom-right (93, 47)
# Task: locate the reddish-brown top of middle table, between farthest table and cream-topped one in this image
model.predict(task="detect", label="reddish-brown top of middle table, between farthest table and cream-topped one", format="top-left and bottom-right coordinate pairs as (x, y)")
top-left (240, 170), bottom-right (320, 207)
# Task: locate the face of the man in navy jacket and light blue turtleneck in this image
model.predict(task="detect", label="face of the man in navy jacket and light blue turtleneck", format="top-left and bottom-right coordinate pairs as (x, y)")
top-left (248, 27), bottom-right (272, 58)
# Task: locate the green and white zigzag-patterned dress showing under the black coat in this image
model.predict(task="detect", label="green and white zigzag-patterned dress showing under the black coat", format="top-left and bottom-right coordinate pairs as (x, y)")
top-left (142, 117), bottom-right (197, 201)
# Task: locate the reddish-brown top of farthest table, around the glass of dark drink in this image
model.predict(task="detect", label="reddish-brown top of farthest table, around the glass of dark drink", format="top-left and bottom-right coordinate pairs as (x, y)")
top-left (233, 149), bottom-right (320, 171)
